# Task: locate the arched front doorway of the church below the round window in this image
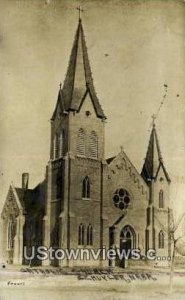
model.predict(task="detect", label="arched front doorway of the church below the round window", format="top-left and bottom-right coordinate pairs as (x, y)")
top-left (119, 225), bottom-right (136, 268)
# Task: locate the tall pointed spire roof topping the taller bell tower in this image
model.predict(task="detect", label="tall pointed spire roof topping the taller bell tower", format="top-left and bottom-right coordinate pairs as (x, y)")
top-left (52, 19), bottom-right (106, 119)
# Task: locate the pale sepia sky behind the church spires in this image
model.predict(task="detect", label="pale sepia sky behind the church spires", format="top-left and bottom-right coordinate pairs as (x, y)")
top-left (0, 0), bottom-right (185, 220)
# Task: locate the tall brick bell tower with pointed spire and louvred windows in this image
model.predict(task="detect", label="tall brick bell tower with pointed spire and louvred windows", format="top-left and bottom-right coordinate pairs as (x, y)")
top-left (44, 17), bottom-right (106, 265)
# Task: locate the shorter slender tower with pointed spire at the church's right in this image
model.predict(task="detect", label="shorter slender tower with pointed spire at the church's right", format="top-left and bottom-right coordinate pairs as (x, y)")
top-left (141, 121), bottom-right (172, 256)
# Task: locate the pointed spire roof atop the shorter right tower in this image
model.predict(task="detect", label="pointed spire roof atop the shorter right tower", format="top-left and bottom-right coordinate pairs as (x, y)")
top-left (141, 124), bottom-right (170, 182)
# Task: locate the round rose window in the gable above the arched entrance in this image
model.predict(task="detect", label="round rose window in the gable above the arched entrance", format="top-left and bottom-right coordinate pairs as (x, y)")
top-left (112, 189), bottom-right (131, 210)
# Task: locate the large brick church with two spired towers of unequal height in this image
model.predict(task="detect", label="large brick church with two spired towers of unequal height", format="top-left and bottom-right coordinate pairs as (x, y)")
top-left (1, 19), bottom-right (172, 266)
